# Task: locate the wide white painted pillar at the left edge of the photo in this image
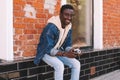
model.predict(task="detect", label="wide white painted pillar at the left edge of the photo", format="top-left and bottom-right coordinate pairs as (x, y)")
top-left (0, 0), bottom-right (13, 61)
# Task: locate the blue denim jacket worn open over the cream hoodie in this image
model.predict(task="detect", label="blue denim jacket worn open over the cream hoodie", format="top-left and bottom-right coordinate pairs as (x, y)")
top-left (34, 23), bottom-right (72, 65)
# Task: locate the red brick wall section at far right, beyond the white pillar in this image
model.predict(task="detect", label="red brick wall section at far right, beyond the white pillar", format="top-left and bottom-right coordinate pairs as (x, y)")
top-left (103, 0), bottom-right (120, 48)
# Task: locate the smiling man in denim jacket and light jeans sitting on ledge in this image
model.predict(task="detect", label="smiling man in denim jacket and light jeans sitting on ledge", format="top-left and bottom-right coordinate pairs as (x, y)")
top-left (34, 4), bottom-right (80, 80)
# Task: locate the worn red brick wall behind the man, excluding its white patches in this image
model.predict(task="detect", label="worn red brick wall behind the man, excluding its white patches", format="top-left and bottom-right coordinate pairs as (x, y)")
top-left (13, 0), bottom-right (60, 57)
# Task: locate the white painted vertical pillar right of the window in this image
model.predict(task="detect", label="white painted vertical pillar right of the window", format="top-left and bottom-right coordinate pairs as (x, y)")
top-left (94, 0), bottom-right (103, 49)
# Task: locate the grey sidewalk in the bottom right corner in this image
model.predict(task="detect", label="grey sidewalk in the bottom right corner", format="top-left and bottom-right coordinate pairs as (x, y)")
top-left (90, 70), bottom-right (120, 80)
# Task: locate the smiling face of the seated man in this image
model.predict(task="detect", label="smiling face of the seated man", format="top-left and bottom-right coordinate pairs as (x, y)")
top-left (60, 9), bottom-right (74, 26)
